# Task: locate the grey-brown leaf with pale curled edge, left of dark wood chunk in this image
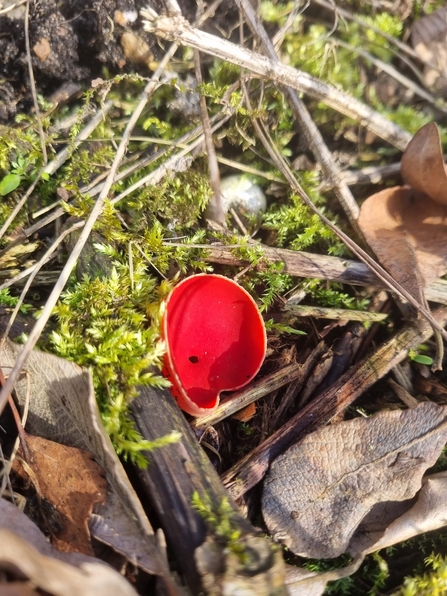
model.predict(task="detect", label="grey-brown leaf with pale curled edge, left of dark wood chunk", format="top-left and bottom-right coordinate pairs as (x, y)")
top-left (0, 342), bottom-right (165, 574)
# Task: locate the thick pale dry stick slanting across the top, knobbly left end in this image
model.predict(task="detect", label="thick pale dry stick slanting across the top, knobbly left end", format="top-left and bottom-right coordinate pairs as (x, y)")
top-left (141, 9), bottom-right (411, 151)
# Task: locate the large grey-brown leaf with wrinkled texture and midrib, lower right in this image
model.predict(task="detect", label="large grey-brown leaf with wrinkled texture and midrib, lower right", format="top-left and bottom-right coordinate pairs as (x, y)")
top-left (262, 402), bottom-right (447, 558)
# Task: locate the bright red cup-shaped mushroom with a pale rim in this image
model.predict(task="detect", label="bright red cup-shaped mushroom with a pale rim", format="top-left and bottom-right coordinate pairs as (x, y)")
top-left (162, 274), bottom-right (267, 416)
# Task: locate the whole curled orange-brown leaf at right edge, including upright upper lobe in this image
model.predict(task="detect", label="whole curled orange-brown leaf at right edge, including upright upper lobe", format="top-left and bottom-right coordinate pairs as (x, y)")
top-left (358, 123), bottom-right (447, 304)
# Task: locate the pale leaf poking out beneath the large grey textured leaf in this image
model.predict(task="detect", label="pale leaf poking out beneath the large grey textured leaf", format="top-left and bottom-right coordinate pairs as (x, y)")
top-left (349, 472), bottom-right (447, 555)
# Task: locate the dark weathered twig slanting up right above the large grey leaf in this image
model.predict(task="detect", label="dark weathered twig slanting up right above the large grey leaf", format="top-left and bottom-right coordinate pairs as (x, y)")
top-left (222, 307), bottom-right (447, 499)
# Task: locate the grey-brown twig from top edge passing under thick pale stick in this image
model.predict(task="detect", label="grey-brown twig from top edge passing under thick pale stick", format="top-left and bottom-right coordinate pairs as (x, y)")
top-left (236, 0), bottom-right (362, 237)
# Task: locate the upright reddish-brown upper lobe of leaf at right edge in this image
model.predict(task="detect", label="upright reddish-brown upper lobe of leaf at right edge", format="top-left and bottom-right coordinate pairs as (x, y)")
top-left (400, 122), bottom-right (447, 205)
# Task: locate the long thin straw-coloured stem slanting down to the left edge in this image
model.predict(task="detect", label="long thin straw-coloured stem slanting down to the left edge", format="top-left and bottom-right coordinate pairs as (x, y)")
top-left (0, 44), bottom-right (181, 412)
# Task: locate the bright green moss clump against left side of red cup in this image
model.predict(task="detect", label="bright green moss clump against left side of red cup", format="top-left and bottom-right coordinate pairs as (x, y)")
top-left (51, 248), bottom-right (171, 465)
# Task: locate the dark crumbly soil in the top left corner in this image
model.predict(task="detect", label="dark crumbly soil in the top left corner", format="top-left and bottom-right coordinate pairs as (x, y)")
top-left (0, 0), bottom-right (231, 123)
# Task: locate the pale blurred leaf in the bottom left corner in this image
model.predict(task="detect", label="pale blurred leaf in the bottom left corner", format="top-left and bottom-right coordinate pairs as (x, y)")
top-left (0, 530), bottom-right (137, 596)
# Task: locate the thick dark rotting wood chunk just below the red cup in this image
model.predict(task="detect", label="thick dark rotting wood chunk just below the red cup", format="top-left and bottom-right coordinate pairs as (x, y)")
top-left (130, 387), bottom-right (285, 596)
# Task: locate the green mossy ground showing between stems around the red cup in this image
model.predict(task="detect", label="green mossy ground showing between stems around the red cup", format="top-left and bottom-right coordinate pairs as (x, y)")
top-left (0, 1), bottom-right (447, 596)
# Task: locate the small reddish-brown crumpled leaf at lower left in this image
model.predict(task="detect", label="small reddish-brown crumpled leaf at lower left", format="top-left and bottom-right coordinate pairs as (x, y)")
top-left (13, 434), bottom-right (107, 556)
